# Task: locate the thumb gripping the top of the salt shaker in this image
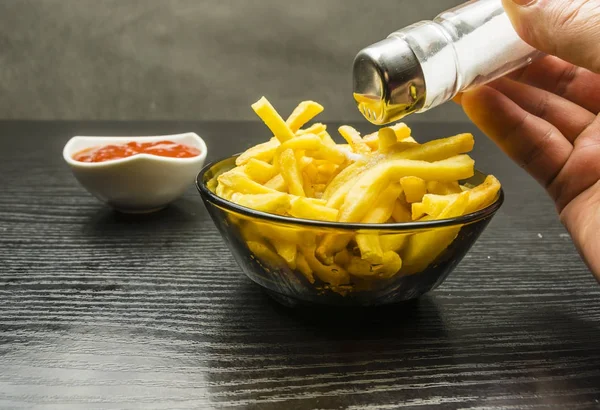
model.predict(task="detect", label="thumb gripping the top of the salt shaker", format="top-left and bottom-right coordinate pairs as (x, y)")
top-left (502, 0), bottom-right (600, 73)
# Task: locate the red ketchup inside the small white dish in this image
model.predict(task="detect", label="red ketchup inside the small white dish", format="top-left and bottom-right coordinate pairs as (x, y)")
top-left (73, 141), bottom-right (200, 162)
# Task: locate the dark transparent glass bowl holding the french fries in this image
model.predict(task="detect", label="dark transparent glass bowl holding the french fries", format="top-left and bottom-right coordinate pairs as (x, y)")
top-left (196, 156), bottom-right (504, 307)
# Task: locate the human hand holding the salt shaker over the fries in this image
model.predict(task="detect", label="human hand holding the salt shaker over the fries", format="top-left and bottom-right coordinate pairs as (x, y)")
top-left (455, 0), bottom-right (600, 280)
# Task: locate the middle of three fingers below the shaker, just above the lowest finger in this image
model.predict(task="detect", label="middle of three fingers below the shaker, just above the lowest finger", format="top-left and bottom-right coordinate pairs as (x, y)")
top-left (490, 78), bottom-right (596, 142)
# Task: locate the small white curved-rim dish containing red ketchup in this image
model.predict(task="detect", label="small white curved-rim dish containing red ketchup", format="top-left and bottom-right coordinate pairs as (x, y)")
top-left (63, 132), bottom-right (207, 213)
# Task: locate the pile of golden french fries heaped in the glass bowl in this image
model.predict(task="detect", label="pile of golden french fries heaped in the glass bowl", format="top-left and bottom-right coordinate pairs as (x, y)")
top-left (214, 97), bottom-right (500, 290)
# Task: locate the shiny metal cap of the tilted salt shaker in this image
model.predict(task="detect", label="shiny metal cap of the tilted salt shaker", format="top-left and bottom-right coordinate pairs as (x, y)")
top-left (353, 35), bottom-right (426, 125)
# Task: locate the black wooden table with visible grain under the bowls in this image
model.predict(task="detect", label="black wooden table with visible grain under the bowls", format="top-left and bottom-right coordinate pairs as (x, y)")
top-left (0, 122), bottom-right (600, 410)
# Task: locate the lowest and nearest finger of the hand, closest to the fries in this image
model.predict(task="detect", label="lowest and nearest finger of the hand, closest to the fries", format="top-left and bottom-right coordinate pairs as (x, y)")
top-left (461, 86), bottom-right (573, 187)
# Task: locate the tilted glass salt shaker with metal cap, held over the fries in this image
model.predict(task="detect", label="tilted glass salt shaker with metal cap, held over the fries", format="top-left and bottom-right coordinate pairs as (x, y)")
top-left (353, 0), bottom-right (542, 125)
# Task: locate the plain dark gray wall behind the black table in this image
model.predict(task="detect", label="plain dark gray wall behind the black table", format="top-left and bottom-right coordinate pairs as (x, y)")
top-left (0, 0), bottom-right (466, 121)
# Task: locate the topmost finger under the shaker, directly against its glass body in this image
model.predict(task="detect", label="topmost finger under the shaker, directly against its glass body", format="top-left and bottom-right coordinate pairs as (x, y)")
top-left (509, 56), bottom-right (600, 114)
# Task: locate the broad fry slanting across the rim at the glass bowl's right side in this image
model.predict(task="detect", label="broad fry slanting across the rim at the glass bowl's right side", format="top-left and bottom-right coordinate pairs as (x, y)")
top-left (402, 191), bottom-right (469, 274)
